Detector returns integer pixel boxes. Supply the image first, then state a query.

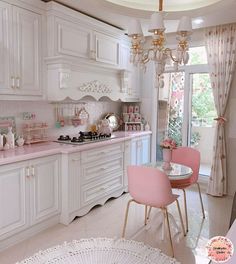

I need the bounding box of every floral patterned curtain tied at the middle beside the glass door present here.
[205,24,236,196]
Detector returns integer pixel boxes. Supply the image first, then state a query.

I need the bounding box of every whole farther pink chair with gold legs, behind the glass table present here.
[170,147,205,232]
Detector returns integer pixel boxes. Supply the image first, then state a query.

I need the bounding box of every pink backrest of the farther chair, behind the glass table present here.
[171,147,200,183]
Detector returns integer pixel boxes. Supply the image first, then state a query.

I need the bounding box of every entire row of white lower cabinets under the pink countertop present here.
[0,135,150,251]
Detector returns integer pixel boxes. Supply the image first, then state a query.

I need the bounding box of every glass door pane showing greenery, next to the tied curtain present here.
[188,73,217,175]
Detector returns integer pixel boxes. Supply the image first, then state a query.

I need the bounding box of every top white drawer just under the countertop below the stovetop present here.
[81,143,124,163]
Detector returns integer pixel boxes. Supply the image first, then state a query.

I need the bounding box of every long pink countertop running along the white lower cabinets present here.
[0,131,151,165]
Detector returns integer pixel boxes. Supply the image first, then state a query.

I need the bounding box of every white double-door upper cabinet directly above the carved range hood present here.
[48,13,120,67]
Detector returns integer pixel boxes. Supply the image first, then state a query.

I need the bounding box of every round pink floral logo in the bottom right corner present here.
[207,236,234,263]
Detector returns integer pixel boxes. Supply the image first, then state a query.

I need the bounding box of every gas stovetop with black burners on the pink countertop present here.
[54,131,114,145]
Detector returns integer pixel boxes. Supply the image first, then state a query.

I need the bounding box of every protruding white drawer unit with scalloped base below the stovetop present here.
[60,142,124,225]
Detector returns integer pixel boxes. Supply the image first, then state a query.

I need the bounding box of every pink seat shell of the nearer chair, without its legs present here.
[128,166,173,207]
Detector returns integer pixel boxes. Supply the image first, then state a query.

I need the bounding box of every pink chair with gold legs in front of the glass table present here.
[122,166,185,256]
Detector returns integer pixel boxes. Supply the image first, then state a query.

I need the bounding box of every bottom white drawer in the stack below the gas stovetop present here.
[81,173,123,207]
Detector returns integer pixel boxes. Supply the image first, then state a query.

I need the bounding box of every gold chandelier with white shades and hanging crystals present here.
[128,0,192,87]
